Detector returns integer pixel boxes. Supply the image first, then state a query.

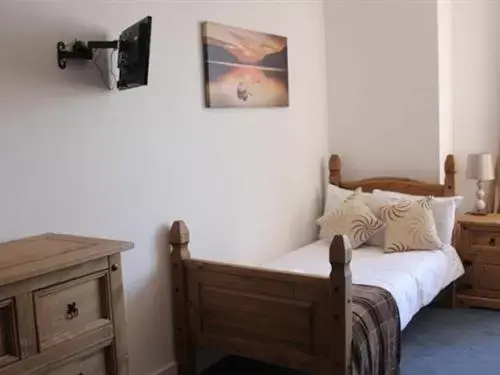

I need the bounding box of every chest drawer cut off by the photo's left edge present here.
[0,299,20,367]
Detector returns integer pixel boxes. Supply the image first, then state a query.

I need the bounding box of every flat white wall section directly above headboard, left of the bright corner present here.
[325,0,441,181]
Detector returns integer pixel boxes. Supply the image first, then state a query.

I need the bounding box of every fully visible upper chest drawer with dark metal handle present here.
[34,271,111,351]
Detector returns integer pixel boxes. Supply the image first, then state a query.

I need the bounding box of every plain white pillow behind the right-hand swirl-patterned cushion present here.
[373,190,464,245]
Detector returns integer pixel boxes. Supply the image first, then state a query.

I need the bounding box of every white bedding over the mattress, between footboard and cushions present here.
[260,240,464,329]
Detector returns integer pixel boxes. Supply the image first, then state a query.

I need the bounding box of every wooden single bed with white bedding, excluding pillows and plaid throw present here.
[169,155,460,375]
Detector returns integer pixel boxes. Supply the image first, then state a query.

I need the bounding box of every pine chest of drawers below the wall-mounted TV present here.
[0,233,133,375]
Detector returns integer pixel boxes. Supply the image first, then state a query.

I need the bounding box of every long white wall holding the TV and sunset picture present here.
[0,0,327,375]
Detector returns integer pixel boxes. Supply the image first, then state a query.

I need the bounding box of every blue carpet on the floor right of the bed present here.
[401,308,500,375]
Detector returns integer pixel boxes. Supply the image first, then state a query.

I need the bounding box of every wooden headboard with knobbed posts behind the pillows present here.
[329,155,455,197]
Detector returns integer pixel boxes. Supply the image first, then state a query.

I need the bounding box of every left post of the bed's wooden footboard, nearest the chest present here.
[169,221,196,375]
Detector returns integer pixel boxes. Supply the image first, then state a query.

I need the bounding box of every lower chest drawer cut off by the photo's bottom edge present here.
[44,348,110,375]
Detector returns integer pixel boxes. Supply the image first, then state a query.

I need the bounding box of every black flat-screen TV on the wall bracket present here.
[117,16,152,90]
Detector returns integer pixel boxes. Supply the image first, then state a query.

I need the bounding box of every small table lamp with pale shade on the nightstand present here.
[466,153,495,215]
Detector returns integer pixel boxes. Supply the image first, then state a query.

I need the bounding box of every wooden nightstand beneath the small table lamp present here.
[456,214,500,309]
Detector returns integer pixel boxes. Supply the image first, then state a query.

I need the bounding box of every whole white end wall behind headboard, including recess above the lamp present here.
[325,0,500,211]
